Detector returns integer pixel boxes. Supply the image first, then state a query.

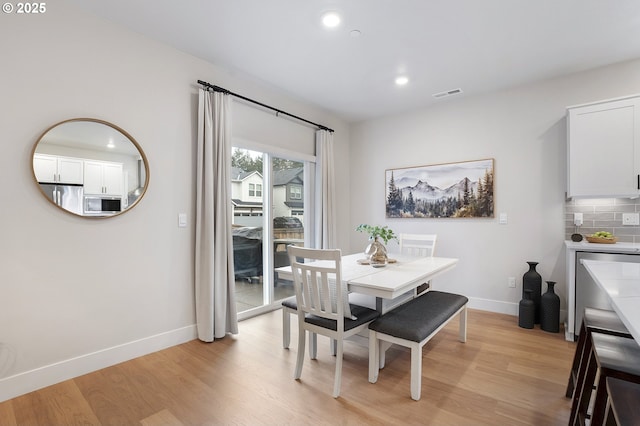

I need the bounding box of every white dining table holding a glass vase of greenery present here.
[276,253,458,311]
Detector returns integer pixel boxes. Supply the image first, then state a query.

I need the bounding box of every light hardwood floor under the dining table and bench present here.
[0,310,575,426]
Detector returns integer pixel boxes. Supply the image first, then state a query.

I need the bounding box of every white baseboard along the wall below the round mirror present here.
[0,325,197,402]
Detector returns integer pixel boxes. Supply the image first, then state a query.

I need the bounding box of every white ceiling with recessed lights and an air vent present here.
[72,0,640,121]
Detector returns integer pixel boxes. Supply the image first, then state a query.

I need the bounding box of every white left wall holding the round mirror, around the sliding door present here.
[0,1,349,401]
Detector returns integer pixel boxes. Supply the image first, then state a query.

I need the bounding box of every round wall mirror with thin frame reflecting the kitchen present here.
[32,118,149,218]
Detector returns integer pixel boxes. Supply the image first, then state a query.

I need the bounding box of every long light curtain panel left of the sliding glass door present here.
[195,89,238,342]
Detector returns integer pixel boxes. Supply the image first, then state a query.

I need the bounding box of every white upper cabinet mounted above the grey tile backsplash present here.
[567,96,640,198]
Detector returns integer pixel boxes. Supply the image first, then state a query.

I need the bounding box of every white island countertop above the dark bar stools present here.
[582,259,640,342]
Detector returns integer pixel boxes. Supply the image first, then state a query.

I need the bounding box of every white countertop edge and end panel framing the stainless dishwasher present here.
[565,240,640,341]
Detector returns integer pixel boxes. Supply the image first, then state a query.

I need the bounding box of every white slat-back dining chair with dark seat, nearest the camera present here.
[288,246,380,398]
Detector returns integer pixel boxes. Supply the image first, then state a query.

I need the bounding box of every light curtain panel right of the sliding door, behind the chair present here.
[315,130,337,249]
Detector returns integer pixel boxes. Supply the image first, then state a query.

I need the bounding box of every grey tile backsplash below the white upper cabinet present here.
[565,198,640,243]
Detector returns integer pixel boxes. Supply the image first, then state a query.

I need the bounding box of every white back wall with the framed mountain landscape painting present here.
[350,61,640,314]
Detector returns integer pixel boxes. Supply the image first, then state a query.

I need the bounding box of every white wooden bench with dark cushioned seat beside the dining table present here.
[369,290,469,401]
